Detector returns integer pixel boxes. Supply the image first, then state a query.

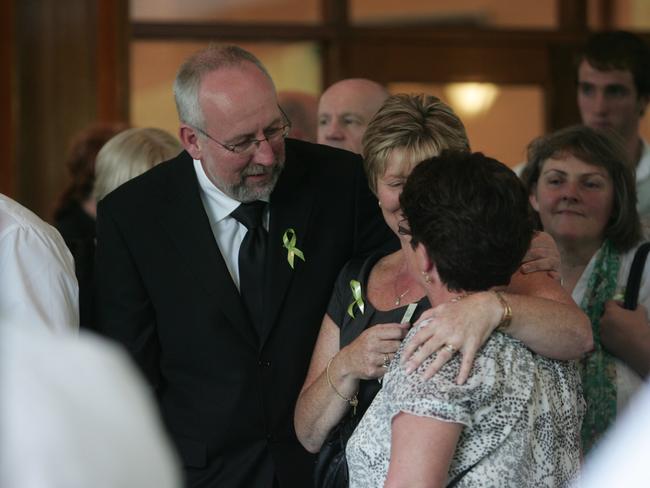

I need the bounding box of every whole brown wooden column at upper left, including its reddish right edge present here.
[13,0,128,218]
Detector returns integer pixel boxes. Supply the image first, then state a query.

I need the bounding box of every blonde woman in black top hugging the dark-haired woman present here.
[294,94,591,487]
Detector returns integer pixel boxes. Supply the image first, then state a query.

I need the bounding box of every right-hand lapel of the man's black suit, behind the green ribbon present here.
[261,147,313,344]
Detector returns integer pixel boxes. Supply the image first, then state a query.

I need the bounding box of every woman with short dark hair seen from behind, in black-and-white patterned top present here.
[347,152,583,488]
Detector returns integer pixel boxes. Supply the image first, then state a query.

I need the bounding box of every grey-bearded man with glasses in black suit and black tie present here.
[96,46,391,488]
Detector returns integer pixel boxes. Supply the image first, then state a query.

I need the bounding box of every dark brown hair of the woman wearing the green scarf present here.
[521,125,641,252]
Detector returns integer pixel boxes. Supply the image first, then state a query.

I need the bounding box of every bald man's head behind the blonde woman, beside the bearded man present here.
[318,78,390,154]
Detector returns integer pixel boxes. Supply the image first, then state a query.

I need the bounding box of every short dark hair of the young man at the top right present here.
[578,31,650,96]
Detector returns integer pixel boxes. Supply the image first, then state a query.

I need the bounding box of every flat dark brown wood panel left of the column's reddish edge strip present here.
[17,0,96,217]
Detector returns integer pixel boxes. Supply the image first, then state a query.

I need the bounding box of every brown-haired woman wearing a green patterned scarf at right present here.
[522,126,650,450]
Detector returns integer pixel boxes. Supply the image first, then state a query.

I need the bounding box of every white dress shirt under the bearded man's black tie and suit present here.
[194,159,269,289]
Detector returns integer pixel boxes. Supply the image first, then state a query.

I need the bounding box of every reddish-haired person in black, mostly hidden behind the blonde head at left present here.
[54,123,127,329]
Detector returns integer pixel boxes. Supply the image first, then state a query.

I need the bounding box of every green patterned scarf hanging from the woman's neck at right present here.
[580,240,620,454]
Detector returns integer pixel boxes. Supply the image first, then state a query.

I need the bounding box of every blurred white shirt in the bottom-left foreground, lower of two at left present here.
[0,322,181,488]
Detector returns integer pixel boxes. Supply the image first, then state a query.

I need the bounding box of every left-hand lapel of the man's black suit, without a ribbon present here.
[159,152,259,347]
